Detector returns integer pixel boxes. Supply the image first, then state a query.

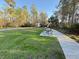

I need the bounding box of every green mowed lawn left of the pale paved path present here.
[0,28,65,59]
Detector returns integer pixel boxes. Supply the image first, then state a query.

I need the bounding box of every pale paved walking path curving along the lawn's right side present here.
[40,29,79,59]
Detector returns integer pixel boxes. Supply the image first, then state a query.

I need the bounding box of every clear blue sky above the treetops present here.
[0,0,59,17]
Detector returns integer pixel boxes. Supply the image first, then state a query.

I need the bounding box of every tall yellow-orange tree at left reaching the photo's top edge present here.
[4,0,16,26]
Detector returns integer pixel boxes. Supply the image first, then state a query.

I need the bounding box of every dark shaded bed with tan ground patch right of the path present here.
[56,29,79,43]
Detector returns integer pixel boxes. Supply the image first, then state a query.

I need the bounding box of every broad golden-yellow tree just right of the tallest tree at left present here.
[14,6,29,27]
